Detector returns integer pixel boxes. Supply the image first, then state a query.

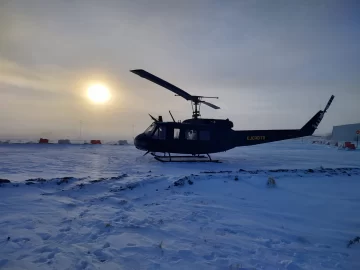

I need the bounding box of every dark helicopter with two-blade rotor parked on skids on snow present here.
[130,69,334,162]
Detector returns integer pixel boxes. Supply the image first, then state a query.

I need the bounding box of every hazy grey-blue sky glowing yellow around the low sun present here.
[0,0,360,139]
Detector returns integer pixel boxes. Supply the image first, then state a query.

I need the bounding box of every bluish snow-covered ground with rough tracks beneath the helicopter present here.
[0,140,360,269]
